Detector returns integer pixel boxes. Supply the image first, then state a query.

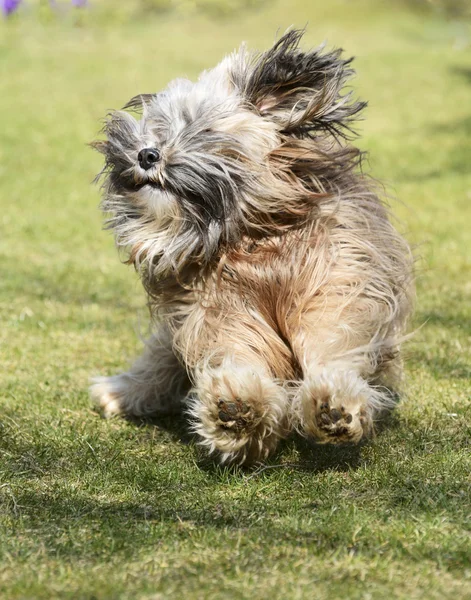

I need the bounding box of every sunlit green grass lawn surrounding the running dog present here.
[0,0,471,600]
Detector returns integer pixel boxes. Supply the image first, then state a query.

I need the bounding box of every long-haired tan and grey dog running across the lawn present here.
[91,30,414,464]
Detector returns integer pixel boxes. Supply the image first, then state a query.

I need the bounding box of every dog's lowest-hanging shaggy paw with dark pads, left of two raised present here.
[190,353,288,464]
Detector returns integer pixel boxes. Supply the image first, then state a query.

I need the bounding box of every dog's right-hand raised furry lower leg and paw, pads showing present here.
[292,311,401,444]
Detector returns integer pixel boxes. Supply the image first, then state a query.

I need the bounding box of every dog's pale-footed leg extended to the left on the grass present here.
[90,326,190,417]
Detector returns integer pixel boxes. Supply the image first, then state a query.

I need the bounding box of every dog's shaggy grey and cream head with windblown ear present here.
[95,31,363,278]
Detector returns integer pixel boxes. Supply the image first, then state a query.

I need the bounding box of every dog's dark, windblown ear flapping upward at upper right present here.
[233,30,366,137]
